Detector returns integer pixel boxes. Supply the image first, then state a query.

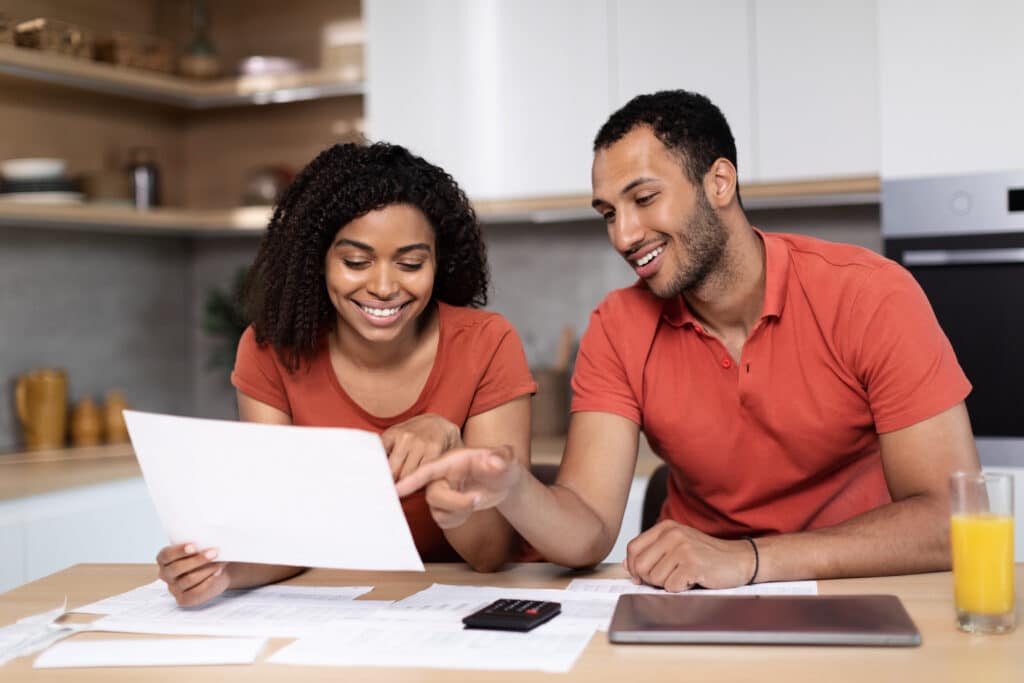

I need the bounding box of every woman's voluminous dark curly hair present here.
[242,142,488,371]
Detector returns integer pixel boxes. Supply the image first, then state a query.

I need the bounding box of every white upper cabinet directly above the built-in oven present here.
[879,0,1024,179]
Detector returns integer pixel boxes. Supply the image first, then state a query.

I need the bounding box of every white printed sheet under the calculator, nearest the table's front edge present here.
[267,616,594,673]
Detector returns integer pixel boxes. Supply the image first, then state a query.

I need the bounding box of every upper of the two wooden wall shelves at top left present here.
[0,45,364,110]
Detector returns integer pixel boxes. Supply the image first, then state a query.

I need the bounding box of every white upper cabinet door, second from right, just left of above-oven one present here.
[753,0,880,181]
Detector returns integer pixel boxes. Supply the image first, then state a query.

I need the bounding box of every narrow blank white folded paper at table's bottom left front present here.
[33,638,266,669]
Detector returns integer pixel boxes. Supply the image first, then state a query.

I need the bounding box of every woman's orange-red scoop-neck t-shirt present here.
[231,302,537,562]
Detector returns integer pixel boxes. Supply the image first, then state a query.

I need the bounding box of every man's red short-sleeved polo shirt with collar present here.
[572,231,971,538]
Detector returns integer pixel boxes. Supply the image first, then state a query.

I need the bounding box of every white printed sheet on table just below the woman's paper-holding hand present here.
[90,586,391,638]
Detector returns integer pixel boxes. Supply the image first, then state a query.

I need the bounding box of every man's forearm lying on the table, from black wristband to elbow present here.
[757,496,950,582]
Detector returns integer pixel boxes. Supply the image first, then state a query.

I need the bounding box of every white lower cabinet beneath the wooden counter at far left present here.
[0,477,167,591]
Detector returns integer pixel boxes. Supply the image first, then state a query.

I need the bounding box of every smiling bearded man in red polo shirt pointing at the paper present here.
[398,91,979,591]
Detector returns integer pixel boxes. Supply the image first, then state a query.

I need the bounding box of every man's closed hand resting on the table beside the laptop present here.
[624,520,754,593]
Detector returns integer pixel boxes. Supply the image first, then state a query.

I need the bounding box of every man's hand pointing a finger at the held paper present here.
[395,449,522,528]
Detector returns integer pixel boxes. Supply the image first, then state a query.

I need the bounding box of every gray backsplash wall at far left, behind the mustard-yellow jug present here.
[0,228,193,450]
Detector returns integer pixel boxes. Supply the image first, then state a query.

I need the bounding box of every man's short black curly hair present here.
[594,90,742,206]
